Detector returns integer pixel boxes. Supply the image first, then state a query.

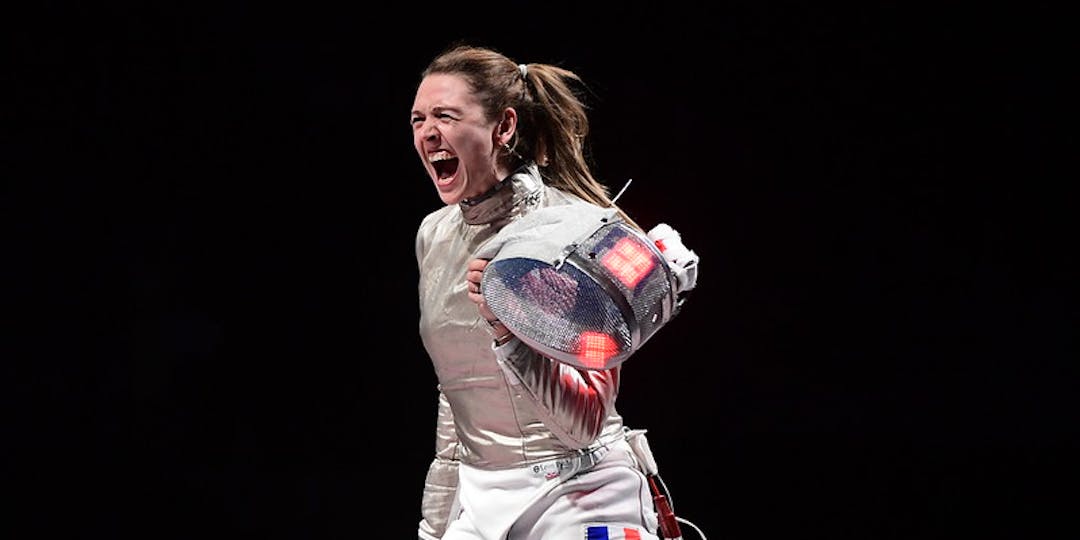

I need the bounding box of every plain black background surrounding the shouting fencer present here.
[3,1,1077,540]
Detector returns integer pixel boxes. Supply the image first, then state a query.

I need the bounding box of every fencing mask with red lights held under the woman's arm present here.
[476,204,698,369]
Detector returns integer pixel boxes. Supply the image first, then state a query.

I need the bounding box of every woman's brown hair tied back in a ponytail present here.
[420,43,640,229]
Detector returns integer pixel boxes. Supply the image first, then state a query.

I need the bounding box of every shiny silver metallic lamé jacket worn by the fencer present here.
[416,165,622,538]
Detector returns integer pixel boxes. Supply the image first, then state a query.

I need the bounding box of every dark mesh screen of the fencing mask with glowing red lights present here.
[481,224,672,368]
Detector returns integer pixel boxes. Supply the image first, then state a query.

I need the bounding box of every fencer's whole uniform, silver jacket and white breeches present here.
[416,165,658,540]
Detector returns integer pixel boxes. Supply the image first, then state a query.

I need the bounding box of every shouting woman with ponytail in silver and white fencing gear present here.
[410,45,695,540]
